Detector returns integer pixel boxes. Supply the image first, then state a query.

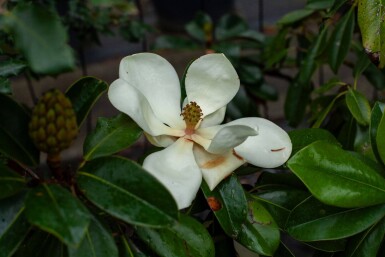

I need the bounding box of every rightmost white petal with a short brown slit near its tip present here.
[228,118,292,168]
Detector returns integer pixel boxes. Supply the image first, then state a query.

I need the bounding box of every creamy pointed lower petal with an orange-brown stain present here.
[194,145,245,190]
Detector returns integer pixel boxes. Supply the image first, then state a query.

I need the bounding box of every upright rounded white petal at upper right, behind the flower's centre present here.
[185,54,239,116]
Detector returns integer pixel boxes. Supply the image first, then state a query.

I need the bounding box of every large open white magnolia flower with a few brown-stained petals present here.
[108,53,292,209]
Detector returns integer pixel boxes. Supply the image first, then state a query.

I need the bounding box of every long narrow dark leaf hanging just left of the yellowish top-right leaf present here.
[328,8,355,73]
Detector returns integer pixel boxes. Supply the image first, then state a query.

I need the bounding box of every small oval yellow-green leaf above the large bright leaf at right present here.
[345,89,370,126]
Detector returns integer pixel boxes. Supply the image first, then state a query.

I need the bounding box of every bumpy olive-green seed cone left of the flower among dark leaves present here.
[29,89,78,154]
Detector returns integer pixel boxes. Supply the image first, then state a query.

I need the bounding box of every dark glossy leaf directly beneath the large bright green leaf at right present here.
[286,197,385,241]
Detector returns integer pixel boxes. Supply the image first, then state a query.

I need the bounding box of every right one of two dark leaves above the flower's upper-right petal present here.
[215,14,249,40]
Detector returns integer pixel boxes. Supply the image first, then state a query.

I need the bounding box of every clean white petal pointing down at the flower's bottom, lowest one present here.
[143,138,202,209]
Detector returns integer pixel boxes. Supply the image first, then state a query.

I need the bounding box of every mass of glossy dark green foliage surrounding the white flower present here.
[0,0,385,254]
